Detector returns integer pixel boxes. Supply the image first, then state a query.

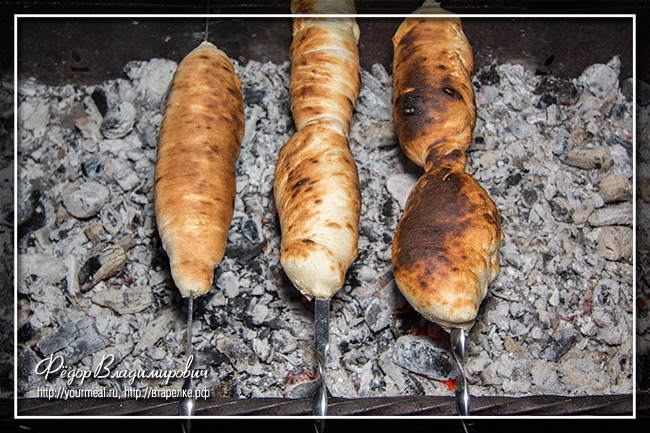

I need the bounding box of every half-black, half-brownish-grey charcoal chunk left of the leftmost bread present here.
[78,244,127,291]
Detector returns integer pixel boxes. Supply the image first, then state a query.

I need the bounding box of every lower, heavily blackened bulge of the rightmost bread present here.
[392,167,503,326]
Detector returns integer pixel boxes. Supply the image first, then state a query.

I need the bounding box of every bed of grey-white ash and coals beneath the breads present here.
[17,51,632,398]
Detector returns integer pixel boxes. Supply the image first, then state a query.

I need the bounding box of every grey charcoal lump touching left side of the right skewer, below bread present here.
[393,335,458,381]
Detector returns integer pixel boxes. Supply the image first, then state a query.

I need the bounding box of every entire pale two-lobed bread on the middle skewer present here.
[274,0,361,299]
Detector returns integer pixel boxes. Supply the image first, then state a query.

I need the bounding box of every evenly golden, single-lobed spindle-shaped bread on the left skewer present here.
[154,42,244,297]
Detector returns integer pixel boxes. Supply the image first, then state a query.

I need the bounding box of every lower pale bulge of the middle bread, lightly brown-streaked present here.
[274,123,361,298]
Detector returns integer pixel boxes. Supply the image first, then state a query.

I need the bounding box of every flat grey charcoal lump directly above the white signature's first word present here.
[37,317,109,365]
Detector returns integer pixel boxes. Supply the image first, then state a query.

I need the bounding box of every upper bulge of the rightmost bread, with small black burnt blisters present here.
[393,11,476,166]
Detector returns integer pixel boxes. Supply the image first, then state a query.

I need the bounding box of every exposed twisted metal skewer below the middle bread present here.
[311,298,330,433]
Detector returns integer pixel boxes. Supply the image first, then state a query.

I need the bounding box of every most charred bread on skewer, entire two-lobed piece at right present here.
[392,2,503,330]
